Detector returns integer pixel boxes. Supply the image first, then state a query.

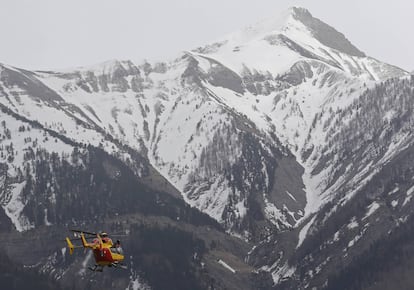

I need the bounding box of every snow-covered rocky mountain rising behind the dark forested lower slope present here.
[0,8,414,288]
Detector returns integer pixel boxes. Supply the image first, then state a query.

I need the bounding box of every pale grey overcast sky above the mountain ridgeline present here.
[0,0,414,71]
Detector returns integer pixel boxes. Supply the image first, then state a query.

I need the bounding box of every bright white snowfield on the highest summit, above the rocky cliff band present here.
[196,8,407,80]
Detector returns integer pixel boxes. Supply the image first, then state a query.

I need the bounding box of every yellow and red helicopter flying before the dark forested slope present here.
[66,229,126,272]
